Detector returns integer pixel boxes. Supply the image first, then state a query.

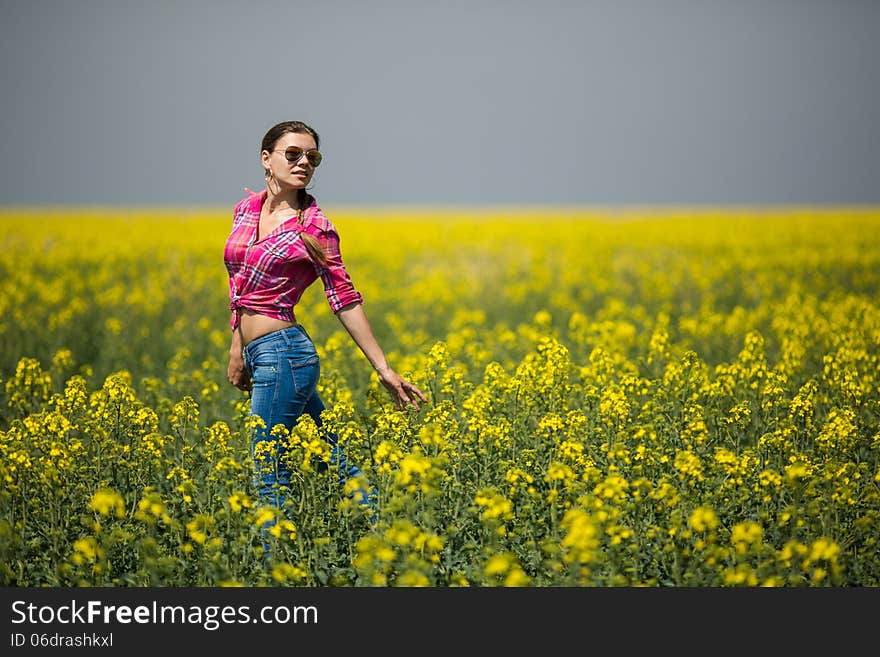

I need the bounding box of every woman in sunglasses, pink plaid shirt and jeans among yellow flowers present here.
[224,121,426,548]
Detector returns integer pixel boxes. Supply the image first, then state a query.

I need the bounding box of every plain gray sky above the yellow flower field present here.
[0,0,880,206]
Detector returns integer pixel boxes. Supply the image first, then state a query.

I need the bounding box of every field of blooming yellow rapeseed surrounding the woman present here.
[0,207,880,587]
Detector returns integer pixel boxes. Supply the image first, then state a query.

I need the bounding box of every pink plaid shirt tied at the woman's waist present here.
[229,190,364,329]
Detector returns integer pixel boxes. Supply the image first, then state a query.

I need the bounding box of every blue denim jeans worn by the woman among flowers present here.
[244,325,377,532]
